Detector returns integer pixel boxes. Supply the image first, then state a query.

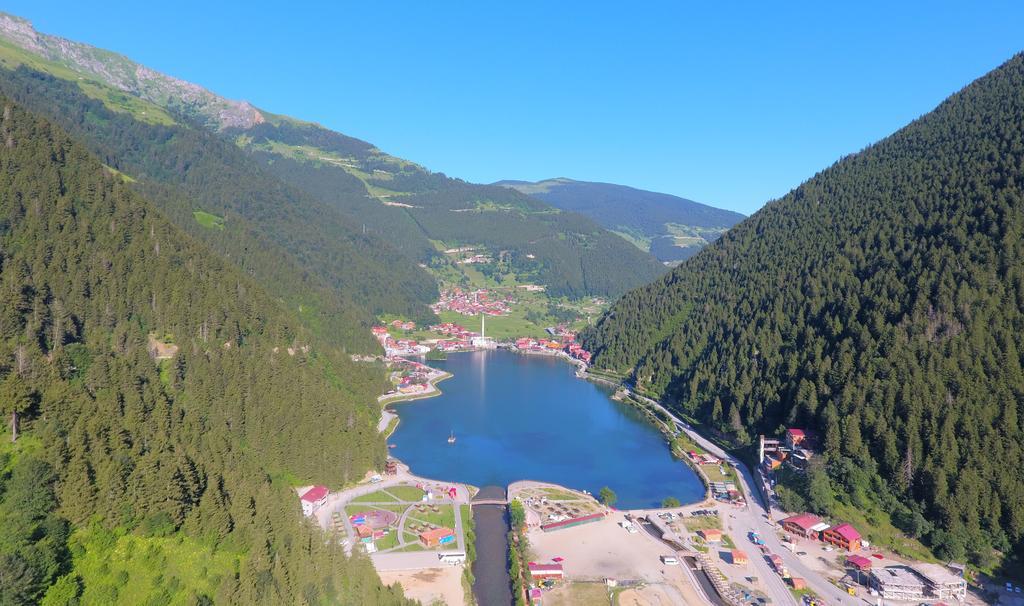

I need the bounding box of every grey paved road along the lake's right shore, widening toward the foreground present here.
[626,388,870,606]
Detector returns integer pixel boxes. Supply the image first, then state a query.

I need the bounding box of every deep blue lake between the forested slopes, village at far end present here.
[390,350,703,509]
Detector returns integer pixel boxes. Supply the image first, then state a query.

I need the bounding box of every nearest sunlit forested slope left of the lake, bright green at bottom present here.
[0,98,402,604]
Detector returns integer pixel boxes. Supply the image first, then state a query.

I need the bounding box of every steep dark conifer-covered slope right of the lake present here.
[584,55,1024,564]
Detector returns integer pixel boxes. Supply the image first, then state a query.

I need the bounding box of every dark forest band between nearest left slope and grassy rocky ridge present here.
[0,67,437,351]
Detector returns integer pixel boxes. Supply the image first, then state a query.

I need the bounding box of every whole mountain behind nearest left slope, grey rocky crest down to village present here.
[0,13,664,303]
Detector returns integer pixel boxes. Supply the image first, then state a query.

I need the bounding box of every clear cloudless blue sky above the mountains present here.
[2,0,1024,214]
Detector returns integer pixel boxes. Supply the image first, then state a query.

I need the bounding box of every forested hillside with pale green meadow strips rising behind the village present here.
[234,105,664,298]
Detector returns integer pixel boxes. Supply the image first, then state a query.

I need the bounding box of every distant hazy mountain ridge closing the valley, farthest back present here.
[495,177,745,263]
